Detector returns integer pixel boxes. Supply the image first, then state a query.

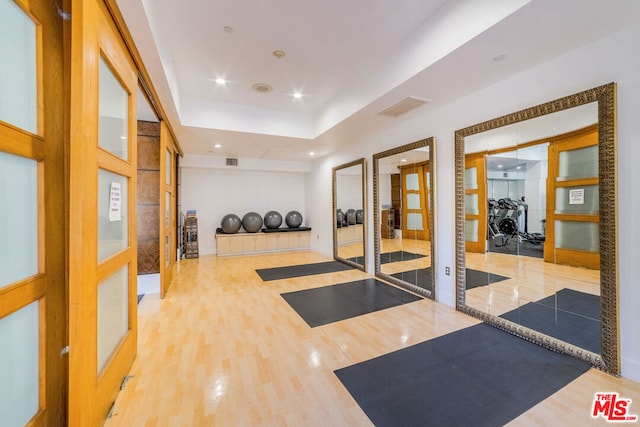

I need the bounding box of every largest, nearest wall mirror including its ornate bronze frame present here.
[455,83,619,374]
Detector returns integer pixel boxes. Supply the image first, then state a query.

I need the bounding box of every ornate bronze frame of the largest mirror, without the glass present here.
[455,83,620,374]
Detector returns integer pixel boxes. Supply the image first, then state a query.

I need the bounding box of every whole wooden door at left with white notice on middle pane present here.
[69,0,138,426]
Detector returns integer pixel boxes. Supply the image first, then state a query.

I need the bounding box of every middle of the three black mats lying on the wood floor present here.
[281,278,422,328]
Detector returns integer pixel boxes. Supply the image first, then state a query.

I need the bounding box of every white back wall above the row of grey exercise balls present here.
[180,156,313,255]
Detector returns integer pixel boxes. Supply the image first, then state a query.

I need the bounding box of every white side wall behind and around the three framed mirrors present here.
[307,25,640,381]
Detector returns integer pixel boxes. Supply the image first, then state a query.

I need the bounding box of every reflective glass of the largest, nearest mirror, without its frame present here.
[465,102,601,354]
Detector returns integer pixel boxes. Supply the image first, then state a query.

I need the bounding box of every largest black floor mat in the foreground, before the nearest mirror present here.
[335,324,589,426]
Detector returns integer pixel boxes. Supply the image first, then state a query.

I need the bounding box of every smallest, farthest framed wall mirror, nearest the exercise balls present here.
[333,159,367,271]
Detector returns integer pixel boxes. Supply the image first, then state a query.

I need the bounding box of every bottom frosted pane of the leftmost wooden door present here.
[0,300,40,427]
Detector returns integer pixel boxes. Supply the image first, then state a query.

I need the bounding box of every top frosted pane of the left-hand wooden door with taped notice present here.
[98,57,129,160]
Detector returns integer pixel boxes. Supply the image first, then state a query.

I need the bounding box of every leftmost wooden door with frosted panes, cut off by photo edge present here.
[0,0,67,426]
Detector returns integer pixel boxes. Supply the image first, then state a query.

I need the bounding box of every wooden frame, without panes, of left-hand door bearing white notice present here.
[68,0,137,426]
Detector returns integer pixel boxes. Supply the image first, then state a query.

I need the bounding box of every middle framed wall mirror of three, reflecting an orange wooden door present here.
[373,138,435,298]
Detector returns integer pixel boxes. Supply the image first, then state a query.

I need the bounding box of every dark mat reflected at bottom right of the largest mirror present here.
[500,289,601,353]
